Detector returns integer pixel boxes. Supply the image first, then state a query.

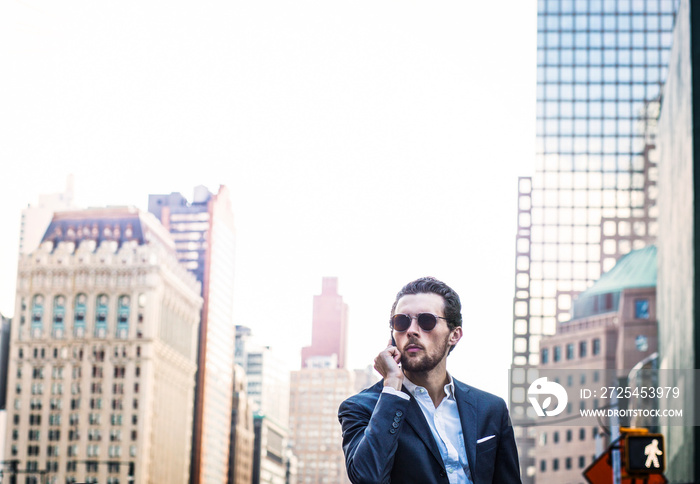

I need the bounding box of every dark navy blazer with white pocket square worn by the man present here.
[338,380,521,484]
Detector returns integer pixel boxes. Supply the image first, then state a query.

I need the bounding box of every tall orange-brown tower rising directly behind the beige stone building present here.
[148,186,236,484]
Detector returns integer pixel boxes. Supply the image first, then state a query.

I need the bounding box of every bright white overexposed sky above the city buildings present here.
[0,0,537,398]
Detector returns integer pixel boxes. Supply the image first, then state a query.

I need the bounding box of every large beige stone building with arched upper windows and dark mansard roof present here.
[4,208,202,484]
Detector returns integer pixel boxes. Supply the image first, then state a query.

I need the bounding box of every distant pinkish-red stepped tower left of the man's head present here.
[301,277,348,368]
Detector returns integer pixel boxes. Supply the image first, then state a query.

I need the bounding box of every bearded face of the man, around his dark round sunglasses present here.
[392,293,462,373]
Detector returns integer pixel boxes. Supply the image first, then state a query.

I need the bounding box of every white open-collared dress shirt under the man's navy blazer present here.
[383,375,473,484]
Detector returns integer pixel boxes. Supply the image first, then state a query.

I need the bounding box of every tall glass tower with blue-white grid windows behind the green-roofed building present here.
[510,0,678,483]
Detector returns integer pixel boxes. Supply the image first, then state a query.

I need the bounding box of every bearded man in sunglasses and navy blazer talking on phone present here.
[338,277,521,484]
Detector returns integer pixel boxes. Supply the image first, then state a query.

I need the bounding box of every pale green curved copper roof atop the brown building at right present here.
[579,245,656,299]
